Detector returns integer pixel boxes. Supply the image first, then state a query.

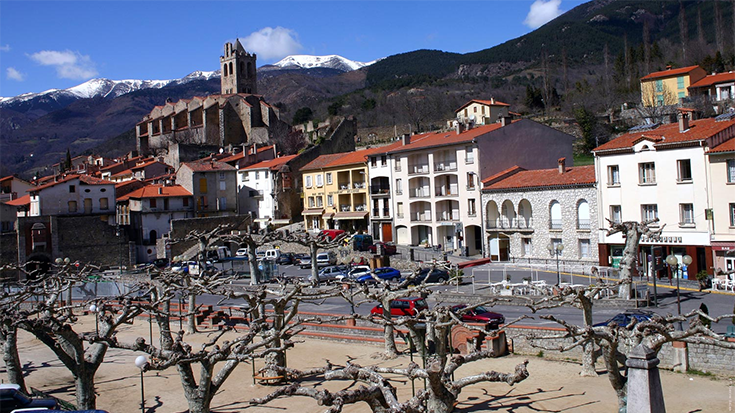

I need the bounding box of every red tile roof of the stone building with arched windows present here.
[483,165,595,191]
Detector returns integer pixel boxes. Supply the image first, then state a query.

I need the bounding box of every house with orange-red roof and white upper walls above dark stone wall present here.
[116,184,194,262]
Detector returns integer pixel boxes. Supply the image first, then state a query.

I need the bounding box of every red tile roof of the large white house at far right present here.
[593,118,735,152]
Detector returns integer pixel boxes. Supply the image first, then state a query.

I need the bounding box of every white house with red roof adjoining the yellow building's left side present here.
[237,155,301,228]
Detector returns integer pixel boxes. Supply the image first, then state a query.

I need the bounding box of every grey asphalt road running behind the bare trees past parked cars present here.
[201,264,735,333]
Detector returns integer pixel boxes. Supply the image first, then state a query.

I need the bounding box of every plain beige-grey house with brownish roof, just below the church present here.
[176,158,237,217]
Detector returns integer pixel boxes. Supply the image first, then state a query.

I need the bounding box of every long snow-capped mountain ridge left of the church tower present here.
[0,70,219,106]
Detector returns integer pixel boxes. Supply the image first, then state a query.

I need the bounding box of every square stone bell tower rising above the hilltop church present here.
[219,40,258,95]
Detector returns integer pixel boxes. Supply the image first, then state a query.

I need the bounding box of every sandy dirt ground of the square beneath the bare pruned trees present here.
[8,316,735,413]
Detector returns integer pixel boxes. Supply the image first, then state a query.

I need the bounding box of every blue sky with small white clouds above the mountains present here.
[0,0,584,97]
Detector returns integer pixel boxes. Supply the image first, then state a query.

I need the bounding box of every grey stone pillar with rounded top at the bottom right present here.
[625,344,666,413]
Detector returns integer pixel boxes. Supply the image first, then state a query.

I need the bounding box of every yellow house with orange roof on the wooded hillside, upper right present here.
[641,66,707,107]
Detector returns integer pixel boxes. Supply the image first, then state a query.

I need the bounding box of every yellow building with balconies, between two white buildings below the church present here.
[301,148,380,232]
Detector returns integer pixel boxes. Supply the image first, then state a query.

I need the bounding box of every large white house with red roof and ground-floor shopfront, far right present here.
[593,109,735,279]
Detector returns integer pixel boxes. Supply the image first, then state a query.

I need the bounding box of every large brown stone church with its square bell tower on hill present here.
[135,40,291,159]
